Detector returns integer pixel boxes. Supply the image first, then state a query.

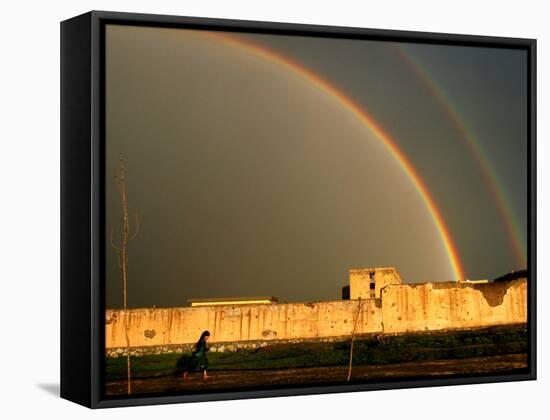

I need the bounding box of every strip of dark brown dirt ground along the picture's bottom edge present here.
[106,354,527,396]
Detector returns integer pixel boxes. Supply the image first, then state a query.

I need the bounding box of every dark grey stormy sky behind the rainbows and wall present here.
[106,26,527,307]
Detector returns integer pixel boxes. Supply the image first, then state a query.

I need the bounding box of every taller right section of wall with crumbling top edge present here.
[382,279,527,333]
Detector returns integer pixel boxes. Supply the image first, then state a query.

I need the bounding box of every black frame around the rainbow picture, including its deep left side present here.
[61,11,537,408]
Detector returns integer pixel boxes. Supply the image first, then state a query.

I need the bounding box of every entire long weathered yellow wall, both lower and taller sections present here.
[105,279,527,349]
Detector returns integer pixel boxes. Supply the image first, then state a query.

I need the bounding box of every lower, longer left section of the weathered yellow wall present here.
[105,299,382,348]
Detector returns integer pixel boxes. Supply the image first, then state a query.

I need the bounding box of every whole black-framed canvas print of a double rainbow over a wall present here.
[61,12,536,408]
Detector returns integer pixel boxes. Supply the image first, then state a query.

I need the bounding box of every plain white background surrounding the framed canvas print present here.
[0,0,550,420]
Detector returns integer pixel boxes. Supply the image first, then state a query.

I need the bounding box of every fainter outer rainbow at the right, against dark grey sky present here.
[393,44,527,268]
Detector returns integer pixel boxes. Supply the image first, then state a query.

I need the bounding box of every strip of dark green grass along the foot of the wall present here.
[106,325,528,380]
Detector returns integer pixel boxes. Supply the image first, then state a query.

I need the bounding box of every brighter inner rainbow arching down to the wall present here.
[204,32,464,281]
